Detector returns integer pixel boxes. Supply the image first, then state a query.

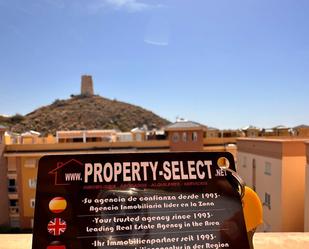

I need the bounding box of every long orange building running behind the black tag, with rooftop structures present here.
[0,127,236,229]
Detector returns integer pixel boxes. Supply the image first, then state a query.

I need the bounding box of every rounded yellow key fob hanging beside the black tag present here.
[242,186,263,232]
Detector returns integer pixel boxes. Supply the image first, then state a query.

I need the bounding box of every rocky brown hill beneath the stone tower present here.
[0,95,169,135]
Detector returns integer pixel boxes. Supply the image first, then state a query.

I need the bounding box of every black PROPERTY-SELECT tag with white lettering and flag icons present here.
[32,152,250,249]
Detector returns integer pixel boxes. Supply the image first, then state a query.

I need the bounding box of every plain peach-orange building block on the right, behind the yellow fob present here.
[237,138,306,232]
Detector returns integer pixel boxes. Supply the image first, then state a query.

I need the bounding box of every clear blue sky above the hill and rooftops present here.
[0,0,309,128]
